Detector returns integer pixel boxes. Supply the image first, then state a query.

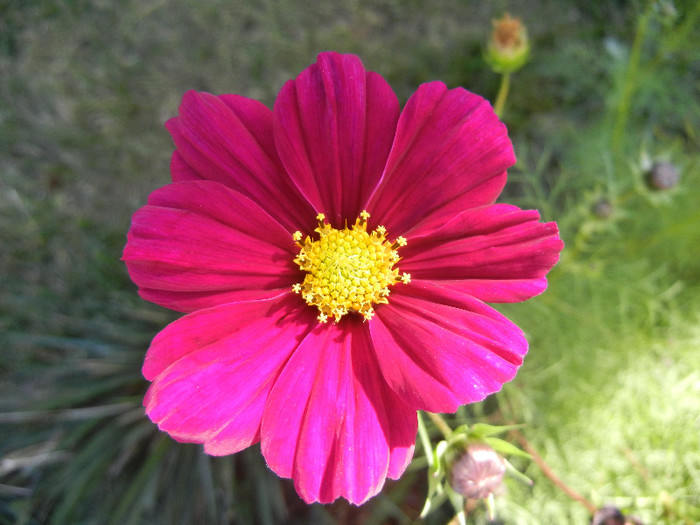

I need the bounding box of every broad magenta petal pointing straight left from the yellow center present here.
[123,181,300,311]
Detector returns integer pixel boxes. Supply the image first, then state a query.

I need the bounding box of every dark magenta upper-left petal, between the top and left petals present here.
[166,91,315,232]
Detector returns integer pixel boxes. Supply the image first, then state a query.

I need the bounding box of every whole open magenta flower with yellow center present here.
[124,53,562,504]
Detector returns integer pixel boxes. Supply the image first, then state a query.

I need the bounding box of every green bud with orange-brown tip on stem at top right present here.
[485,13,530,73]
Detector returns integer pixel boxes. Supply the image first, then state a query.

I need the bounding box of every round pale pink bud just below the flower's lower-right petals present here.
[448,442,506,499]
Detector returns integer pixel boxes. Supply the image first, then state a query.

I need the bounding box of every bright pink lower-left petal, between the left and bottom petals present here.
[143,294,316,455]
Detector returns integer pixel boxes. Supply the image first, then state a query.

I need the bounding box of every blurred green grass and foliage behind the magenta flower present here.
[0,0,700,525]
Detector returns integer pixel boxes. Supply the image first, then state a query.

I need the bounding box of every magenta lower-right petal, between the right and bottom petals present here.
[369,281,527,412]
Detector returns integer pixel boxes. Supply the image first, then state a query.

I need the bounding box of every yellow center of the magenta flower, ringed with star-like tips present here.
[292,211,411,323]
